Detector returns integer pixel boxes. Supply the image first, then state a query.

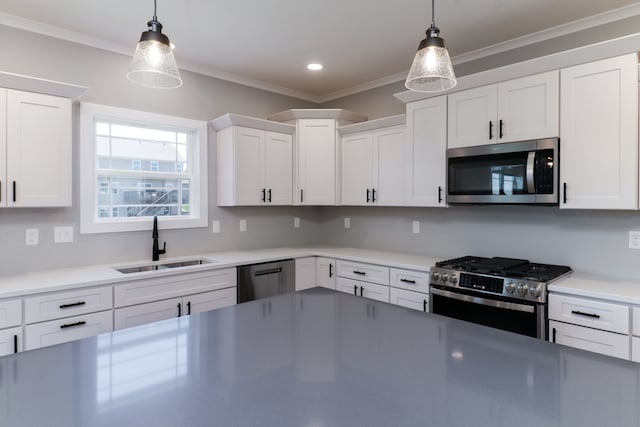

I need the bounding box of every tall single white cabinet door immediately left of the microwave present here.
[406,96,447,207]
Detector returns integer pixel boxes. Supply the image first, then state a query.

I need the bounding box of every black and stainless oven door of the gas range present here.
[430,285,546,339]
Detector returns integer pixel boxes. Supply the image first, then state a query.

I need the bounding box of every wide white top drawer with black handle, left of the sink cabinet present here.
[24,286,113,323]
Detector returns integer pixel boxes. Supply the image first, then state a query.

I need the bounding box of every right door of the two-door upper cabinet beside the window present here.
[264,132,293,205]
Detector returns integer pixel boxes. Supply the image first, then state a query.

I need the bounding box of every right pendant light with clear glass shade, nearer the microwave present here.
[404,0,458,92]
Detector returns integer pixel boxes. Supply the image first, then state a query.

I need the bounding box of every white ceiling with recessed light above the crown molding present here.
[0,0,640,100]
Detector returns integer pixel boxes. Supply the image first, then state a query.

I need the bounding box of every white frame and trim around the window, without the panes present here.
[80,102,209,234]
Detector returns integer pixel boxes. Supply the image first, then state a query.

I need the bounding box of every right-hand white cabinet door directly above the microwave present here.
[498,71,560,142]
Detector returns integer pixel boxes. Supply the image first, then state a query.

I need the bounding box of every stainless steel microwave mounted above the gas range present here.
[447,138,560,205]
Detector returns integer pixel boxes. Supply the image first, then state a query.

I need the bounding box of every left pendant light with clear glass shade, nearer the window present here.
[127,0,182,89]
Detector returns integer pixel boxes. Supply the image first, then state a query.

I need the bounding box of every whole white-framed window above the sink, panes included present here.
[80,103,207,233]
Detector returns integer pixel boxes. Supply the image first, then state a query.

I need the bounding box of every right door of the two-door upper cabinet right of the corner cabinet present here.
[372,125,407,206]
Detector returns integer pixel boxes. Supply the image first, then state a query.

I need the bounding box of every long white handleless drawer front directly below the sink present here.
[114,268,236,307]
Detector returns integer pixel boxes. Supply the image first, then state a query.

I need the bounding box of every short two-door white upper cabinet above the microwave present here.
[448,71,559,148]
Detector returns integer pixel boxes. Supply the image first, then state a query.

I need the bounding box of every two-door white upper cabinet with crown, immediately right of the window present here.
[212,114,295,206]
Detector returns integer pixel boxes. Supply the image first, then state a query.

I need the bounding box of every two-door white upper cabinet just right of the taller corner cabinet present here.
[339,115,407,206]
